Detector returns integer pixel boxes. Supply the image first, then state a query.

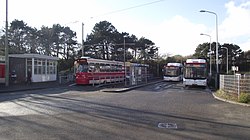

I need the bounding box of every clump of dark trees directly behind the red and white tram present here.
[84,21,158,62]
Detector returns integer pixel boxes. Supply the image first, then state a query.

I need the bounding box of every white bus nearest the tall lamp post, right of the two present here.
[183,59,207,87]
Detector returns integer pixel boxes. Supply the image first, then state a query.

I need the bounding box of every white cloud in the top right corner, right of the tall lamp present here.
[219,1,250,51]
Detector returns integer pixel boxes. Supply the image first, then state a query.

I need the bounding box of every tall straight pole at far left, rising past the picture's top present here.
[5,0,9,86]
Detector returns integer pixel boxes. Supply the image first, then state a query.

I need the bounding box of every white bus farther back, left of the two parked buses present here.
[163,63,183,81]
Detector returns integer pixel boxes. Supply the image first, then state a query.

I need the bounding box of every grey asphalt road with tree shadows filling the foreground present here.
[0,82,250,140]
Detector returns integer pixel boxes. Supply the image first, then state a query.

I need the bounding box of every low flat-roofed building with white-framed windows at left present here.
[9,54,59,83]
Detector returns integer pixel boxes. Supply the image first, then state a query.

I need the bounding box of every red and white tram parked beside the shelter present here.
[75,57,124,85]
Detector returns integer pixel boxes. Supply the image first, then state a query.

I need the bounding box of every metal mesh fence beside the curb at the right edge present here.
[220,74,250,98]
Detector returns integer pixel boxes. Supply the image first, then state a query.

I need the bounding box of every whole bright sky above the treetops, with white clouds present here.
[0,0,250,56]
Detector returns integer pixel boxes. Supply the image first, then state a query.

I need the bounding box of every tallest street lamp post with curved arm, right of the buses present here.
[200,10,219,89]
